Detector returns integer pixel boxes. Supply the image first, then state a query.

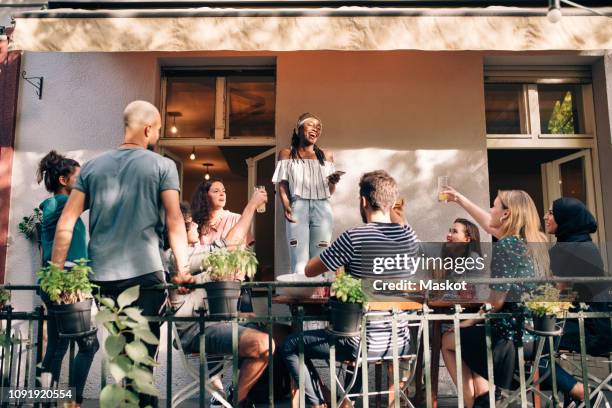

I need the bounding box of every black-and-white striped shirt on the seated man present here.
[319,223,420,354]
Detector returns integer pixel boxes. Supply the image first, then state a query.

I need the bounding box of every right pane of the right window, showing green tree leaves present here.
[538,84,584,134]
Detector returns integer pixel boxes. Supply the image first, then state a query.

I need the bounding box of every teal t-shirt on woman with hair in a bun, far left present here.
[39,194,87,266]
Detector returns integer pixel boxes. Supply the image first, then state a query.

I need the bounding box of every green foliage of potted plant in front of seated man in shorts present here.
[202,248,257,281]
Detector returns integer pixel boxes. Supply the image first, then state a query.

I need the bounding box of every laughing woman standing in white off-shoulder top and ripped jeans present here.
[272,113,340,273]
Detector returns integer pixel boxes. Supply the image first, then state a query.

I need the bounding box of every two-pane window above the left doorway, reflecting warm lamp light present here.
[163,69,276,144]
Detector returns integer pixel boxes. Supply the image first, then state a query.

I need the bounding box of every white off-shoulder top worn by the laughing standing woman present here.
[272,159,336,200]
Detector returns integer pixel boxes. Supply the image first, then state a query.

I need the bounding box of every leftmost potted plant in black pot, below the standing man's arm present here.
[36,259,95,337]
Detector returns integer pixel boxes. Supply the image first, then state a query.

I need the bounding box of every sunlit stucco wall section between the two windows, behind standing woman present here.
[276,52,488,275]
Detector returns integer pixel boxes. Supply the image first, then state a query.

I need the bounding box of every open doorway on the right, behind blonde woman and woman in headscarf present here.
[488,149,600,242]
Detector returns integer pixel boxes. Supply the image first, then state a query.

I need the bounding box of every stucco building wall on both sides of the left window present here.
[6,52,488,398]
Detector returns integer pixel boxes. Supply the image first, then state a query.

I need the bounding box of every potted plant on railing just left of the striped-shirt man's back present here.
[329,273,366,335]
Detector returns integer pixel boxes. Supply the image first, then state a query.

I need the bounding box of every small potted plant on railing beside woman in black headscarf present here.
[522,285,572,332]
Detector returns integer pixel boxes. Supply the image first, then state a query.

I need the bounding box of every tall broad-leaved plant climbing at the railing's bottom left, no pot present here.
[96,286,159,408]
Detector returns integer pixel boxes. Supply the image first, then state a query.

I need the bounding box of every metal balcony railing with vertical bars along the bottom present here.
[0,277,612,408]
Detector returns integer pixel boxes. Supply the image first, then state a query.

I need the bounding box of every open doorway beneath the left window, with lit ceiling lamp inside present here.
[161,145,275,281]
